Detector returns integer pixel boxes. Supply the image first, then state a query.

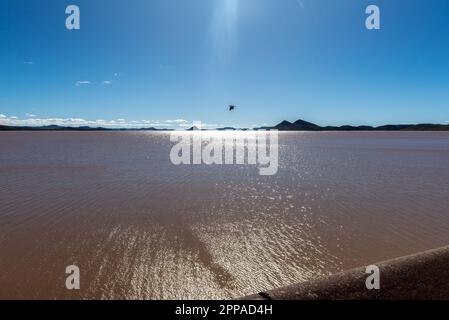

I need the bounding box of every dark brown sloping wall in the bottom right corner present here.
[243,246,449,300]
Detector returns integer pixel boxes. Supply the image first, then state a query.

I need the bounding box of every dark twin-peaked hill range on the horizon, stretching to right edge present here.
[272,120,449,131]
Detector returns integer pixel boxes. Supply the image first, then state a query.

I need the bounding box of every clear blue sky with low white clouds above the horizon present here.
[0,0,449,127]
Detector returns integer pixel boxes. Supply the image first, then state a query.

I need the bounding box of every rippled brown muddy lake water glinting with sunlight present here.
[0,132,449,299]
